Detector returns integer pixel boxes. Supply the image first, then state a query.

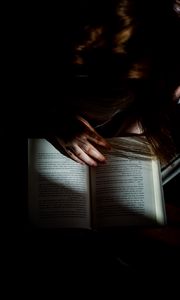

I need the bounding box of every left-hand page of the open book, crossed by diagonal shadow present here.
[28,139,90,228]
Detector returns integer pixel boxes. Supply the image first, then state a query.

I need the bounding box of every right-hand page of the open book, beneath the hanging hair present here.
[91,138,166,228]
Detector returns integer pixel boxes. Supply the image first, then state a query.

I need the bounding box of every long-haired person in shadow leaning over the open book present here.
[43,0,180,166]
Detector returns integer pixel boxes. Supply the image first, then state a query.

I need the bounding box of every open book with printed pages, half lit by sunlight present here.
[28,137,166,229]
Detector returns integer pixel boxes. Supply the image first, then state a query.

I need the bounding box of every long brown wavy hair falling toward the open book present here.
[60,0,180,160]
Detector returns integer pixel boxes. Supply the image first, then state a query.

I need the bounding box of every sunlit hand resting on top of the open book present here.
[48,116,111,166]
